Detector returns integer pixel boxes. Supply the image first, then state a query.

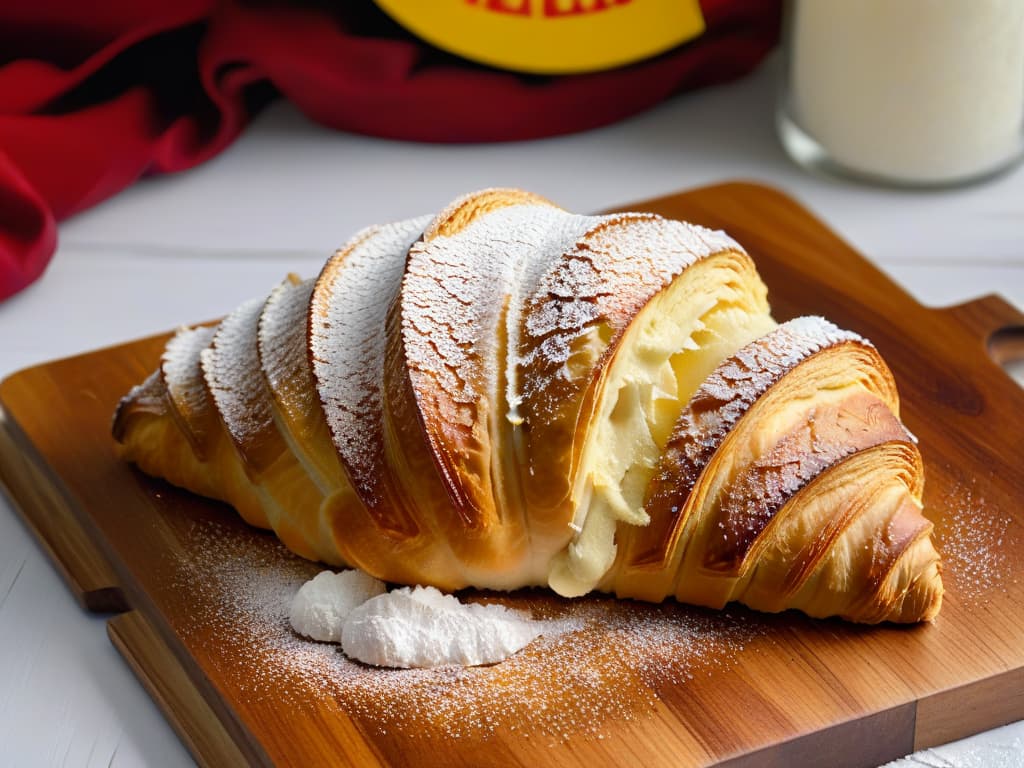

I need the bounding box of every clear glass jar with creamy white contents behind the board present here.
[776,0,1024,186]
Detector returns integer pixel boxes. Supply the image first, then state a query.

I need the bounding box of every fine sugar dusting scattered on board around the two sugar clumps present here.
[174,521,764,739]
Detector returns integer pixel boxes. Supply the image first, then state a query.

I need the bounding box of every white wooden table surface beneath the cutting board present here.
[0,61,1024,768]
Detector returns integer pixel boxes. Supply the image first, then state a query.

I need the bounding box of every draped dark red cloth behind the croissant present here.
[0,0,779,299]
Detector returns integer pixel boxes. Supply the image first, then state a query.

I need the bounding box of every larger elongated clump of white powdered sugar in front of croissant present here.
[341,587,544,669]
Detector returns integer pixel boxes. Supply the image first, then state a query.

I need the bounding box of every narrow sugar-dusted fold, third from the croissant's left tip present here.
[200,299,278,470]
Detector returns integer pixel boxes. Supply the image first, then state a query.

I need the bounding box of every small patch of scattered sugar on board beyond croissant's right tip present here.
[935,482,1014,601]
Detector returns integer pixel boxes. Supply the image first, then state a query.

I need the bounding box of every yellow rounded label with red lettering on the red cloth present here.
[376,0,705,75]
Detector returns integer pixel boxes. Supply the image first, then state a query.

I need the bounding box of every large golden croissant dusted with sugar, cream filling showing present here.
[113,189,942,623]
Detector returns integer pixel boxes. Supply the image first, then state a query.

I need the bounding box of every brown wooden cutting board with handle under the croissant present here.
[6,183,1024,768]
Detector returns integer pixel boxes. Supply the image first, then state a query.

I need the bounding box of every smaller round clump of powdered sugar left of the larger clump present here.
[288,569,386,643]
